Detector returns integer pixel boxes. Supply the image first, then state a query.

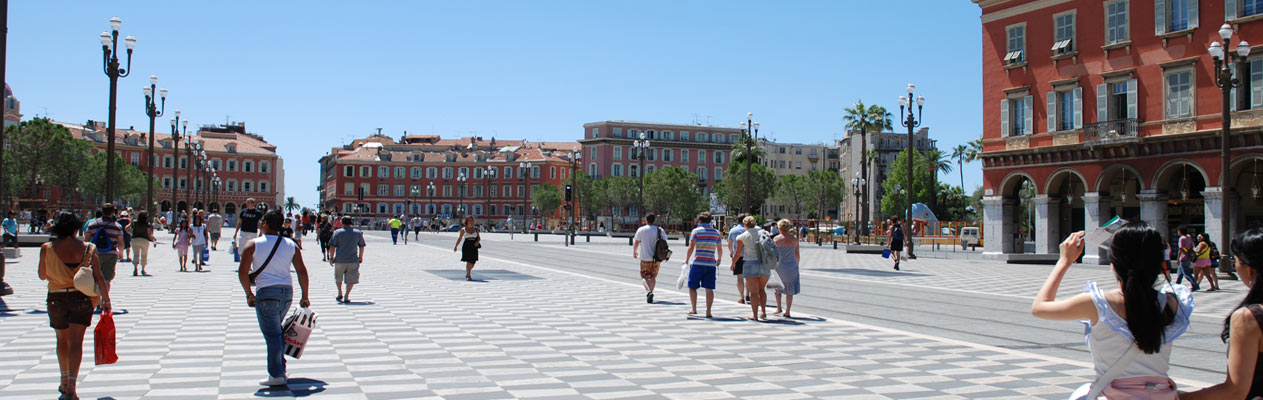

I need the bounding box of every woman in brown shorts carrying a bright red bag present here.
[38,212,111,399]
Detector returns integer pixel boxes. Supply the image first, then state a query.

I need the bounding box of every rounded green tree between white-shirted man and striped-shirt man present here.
[644,167,710,227]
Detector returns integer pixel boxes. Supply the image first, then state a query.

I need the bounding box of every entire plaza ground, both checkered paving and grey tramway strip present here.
[0,231,1244,399]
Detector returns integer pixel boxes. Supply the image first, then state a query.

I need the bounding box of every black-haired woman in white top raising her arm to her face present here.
[1031,221,1192,399]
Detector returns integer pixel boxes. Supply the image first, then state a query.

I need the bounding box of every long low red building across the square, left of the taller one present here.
[317,134,581,227]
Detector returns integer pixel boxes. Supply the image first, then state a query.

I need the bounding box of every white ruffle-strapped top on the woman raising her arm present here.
[1081,281,1192,379]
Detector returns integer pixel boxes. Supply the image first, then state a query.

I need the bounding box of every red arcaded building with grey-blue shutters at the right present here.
[971,0,1263,262]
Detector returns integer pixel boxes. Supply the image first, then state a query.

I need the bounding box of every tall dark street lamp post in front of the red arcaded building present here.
[1210,23,1250,274]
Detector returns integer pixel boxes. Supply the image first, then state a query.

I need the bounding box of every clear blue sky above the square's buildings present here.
[8,0,983,206]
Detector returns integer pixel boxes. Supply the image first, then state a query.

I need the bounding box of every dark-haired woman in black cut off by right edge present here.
[1180,228,1263,400]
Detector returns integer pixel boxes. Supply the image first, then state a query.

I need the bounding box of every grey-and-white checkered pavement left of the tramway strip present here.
[0,232,1182,399]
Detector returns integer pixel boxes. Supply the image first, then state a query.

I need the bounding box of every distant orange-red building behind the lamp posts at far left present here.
[56,121,285,222]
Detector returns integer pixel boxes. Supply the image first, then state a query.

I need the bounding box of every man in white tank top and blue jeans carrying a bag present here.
[237,209,311,386]
